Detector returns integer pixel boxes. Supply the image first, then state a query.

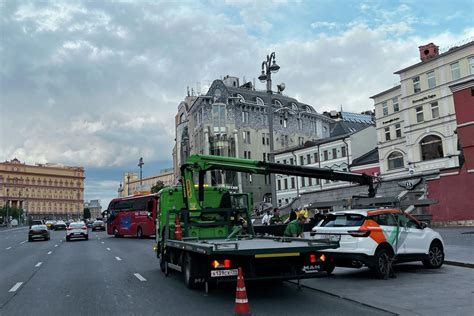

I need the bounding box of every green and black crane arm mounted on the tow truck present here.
[181,155,375,210]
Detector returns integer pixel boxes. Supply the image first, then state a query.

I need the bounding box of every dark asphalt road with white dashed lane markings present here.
[0,229,391,315]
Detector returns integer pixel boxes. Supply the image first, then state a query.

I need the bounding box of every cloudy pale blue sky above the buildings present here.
[0,0,474,208]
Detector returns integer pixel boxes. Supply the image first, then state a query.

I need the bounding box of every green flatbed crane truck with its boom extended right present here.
[155,155,374,291]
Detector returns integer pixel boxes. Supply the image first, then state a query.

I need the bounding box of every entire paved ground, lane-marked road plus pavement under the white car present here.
[0,228,474,315]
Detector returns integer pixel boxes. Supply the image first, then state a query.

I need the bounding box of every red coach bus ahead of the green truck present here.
[104,193,158,238]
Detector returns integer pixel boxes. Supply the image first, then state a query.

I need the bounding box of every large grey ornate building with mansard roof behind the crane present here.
[173,76,333,202]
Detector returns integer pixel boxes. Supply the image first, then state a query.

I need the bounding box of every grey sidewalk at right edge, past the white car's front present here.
[434,227,474,268]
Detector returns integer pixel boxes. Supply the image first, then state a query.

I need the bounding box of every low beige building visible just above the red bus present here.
[119,168,175,197]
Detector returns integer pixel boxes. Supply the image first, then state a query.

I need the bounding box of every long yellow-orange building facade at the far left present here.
[0,158,85,219]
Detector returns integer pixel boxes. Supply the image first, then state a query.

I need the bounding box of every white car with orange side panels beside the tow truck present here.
[311,209,444,278]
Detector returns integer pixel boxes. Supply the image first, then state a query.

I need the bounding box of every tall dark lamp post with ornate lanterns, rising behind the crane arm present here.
[258,52,280,207]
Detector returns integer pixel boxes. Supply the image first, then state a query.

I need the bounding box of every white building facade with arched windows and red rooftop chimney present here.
[371,42,474,179]
